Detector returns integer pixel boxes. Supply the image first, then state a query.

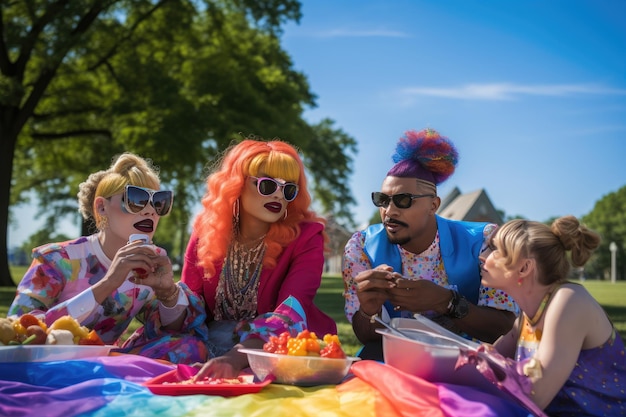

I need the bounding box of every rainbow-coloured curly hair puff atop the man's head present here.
[387,129,459,185]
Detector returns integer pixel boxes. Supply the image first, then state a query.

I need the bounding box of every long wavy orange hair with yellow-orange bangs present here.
[194,139,328,279]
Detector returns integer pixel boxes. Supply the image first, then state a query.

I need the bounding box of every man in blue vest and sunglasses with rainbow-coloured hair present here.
[343,129,517,361]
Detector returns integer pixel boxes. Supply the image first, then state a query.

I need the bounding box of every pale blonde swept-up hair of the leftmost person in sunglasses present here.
[78,152,161,228]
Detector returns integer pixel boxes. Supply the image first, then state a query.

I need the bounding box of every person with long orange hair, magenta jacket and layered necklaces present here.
[181,139,337,378]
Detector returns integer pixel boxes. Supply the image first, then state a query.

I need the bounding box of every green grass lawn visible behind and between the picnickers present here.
[0,267,626,355]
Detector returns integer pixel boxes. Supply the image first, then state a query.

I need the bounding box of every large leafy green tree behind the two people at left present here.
[0,0,356,285]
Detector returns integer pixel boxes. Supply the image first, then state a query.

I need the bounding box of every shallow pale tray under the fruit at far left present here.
[0,345,115,362]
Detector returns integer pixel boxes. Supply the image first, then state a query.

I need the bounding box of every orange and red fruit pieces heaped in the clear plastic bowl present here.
[263,330,346,359]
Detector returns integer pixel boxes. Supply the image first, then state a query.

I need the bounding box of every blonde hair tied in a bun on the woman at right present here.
[493,216,601,285]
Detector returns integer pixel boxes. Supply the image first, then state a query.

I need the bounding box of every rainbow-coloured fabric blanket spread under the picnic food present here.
[0,355,532,417]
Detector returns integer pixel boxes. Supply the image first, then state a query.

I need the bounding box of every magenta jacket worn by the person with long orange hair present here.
[181,223,337,335]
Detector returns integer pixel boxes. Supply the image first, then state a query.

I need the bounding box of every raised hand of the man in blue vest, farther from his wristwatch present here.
[354,265,399,315]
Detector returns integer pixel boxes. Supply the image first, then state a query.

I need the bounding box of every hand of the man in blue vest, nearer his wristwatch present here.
[387,278,452,314]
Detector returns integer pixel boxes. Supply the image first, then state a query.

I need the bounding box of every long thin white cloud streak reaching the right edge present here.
[401,83,626,101]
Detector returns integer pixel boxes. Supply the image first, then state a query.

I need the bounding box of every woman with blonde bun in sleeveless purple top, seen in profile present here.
[482,216,626,416]
